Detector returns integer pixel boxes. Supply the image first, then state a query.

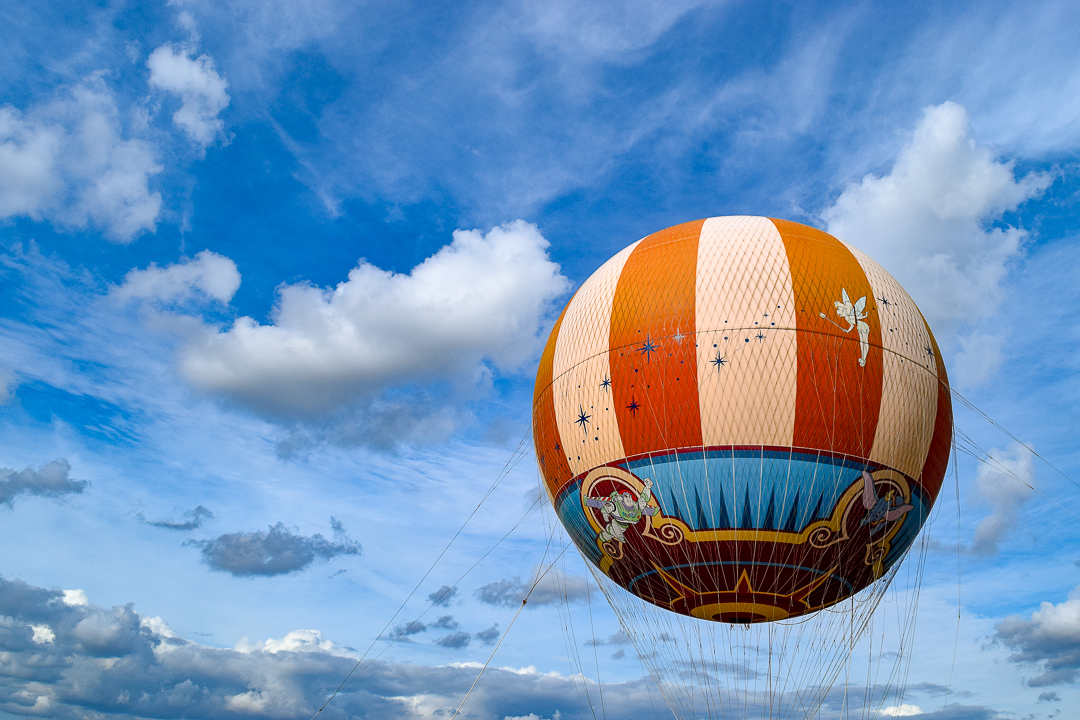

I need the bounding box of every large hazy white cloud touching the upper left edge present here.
[0,78,161,243]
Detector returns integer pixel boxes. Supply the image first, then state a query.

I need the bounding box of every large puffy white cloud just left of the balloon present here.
[180,220,568,419]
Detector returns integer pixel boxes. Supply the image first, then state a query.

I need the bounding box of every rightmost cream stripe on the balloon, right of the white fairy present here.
[845,243,937,478]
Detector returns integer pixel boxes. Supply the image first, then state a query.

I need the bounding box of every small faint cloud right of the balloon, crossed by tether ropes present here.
[969,443,1035,556]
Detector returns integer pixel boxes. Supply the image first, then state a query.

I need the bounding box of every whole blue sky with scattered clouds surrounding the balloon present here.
[0,0,1080,720]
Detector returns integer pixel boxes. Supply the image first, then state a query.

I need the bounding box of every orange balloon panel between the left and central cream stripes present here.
[608,220,705,456]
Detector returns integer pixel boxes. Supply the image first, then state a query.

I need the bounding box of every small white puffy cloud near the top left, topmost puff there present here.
[146,44,229,148]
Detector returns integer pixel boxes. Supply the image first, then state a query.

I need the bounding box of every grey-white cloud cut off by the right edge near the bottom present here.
[994,587,1080,688]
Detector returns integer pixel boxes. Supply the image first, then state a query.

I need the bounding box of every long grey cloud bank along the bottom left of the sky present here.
[0,578,673,720]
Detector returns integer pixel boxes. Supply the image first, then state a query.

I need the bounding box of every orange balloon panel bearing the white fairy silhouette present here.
[770,218,883,458]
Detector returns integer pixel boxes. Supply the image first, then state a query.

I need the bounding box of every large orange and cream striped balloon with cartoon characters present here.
[532,216,953,710]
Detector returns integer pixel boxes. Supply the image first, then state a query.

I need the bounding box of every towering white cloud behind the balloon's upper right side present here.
[822,103,1051,356]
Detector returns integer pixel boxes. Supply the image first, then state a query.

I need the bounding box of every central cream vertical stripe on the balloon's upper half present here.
[696,216,797,447]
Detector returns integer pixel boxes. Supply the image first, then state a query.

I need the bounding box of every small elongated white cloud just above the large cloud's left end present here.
[112,250,240,303]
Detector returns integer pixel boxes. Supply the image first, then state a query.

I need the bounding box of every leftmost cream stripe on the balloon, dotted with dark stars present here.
[552,241,640,476]
